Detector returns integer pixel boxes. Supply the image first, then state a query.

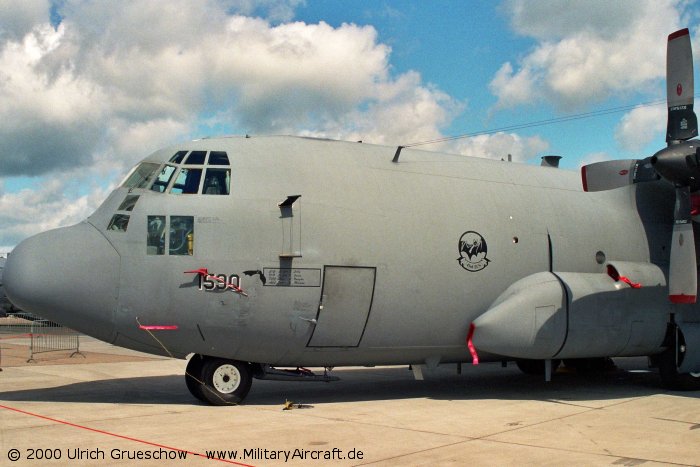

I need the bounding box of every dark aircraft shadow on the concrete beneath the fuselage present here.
[0,365,700,405]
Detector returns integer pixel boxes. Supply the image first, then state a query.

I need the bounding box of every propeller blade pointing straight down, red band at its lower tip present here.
[668,186,698,303]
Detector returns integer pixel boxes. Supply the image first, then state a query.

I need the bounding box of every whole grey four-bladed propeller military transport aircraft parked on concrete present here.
[4,29,700,405]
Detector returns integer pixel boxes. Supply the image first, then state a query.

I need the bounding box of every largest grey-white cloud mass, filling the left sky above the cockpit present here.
[0,0,482,249]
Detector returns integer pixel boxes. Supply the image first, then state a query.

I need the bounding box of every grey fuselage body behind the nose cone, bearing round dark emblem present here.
[31,137,695,366]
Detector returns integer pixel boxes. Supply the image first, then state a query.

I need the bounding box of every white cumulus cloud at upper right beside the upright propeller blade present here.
[490,0,682,111]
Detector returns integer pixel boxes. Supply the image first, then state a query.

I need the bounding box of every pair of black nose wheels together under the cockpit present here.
[185,355,253,405]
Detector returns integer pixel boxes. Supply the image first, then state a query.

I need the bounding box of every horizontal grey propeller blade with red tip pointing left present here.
[581,157,661,191]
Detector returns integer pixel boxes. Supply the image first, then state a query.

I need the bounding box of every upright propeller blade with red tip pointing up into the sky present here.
[666,28,698,143]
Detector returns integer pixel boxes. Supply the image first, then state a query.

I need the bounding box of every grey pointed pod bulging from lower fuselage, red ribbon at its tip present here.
[472,261,669,359]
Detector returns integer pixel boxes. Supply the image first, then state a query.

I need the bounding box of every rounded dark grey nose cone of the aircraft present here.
[3,222,119,341]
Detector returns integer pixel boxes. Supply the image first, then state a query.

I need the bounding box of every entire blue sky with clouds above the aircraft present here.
[0,0,700,253]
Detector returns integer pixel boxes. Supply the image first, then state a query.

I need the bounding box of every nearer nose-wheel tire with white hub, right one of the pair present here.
[201,358,253,405]
